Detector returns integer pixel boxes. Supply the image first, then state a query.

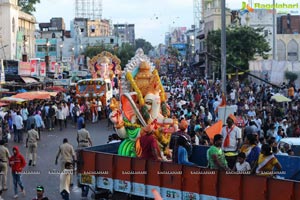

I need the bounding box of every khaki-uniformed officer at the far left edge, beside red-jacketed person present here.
[0,140,10,190]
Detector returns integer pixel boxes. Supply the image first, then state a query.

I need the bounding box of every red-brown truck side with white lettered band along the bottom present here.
[78,144,300,200]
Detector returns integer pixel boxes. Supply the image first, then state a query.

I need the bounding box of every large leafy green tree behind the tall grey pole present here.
[206,26,271,73]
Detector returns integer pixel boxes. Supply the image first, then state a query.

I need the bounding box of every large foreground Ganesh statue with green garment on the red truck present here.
[109,49,178,158]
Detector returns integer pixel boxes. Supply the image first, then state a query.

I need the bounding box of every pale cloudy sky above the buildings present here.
[34,0,297,45]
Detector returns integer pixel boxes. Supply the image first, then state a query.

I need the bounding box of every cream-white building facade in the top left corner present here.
[0,0,36,60]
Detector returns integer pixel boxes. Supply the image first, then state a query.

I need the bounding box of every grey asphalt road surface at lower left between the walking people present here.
[2,119,113,200]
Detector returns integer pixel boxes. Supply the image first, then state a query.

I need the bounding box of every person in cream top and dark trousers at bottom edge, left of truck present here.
[59,162,73,200]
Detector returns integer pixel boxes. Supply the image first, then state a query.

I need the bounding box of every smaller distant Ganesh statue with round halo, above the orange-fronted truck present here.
[88,51,121,80]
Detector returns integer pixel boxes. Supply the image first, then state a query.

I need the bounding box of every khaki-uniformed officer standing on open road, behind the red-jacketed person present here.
[26,124,39,166]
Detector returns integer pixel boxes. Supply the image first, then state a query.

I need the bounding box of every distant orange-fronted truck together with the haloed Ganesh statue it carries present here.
[76,51,121,105]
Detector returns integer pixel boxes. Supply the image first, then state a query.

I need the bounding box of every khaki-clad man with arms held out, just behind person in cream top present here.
[55,138,76,185]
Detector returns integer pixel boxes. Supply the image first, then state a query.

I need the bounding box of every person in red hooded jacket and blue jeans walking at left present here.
[9,146,26,199]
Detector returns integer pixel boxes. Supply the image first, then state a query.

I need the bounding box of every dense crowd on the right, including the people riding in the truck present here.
[157,68,300,176]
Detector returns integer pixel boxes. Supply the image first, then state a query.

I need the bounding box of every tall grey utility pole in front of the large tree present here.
[221,0,226,96]
